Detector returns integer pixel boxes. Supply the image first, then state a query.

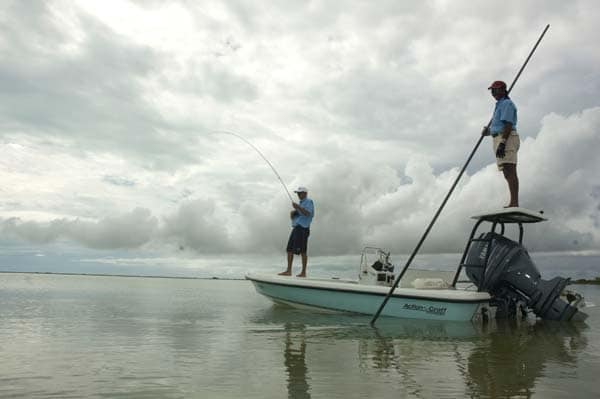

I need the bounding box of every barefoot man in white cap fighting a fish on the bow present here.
[279,186,315,277]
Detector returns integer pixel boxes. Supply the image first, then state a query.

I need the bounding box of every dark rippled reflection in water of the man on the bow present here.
[284,323,310,399]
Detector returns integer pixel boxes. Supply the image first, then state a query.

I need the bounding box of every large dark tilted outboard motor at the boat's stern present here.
[464,232,582,321]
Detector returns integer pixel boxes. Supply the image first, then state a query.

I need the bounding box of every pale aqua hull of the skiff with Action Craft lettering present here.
[246,274,490,321]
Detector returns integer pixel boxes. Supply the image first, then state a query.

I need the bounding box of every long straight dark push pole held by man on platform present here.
[371,24,550,326]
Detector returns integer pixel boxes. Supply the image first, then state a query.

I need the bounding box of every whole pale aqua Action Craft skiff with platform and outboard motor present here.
[246,207,587,321]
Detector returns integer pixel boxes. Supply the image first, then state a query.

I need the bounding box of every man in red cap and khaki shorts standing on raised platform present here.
[482,80,521,208]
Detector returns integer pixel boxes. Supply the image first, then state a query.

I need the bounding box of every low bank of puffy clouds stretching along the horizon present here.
[2,108,600,255]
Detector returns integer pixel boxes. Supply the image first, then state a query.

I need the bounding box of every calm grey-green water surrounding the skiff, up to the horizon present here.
[0,274,600,398]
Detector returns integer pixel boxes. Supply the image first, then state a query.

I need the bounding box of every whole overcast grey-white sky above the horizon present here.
[0,0,600,255]
